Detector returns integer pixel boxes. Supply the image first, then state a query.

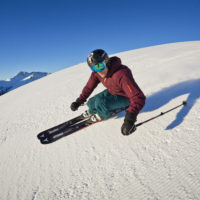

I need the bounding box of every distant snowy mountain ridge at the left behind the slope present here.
[0,71,49,96]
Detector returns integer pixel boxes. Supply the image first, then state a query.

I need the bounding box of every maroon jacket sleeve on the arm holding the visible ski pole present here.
[119,71,146,115]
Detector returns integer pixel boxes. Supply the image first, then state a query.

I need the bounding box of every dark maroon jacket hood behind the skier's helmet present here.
[106,56,122,77]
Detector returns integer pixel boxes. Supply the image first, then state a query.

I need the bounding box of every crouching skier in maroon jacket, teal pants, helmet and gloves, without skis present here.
[71,49,145,135]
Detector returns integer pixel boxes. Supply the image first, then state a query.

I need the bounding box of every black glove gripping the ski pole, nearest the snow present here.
[121,112,136,135]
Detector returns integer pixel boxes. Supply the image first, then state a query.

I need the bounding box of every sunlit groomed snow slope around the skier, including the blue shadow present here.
[0,41,200,200]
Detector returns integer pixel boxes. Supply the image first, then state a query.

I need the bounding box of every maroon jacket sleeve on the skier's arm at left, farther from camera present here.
[79,72,100,102]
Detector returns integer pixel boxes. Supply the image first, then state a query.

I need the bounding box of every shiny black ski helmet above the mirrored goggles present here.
[87,49,109,67]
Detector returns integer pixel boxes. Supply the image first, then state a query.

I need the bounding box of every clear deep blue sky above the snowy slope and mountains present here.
[0,0,200,80]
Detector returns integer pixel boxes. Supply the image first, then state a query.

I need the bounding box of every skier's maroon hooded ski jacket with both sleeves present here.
[79,57,146,115]
